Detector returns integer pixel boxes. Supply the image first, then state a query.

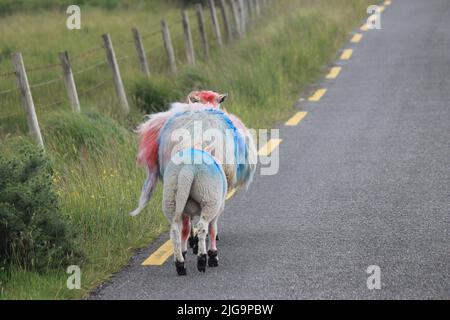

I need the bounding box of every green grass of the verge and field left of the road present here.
[0,0,369,299]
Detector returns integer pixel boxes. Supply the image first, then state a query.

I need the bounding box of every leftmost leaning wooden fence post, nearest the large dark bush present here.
[12,52,44,149]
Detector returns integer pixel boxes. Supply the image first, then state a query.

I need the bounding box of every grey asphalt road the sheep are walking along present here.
[91,0,450,299]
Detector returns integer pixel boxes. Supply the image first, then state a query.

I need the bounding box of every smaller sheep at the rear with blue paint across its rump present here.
[163,148,227,276]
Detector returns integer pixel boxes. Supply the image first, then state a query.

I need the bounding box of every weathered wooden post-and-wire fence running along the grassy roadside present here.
[0,0,270,147]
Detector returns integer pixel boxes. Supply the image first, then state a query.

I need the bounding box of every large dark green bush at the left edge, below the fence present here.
[0,139,80,272]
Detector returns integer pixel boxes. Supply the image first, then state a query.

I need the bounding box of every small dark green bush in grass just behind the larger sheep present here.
[132,80,181,114]
